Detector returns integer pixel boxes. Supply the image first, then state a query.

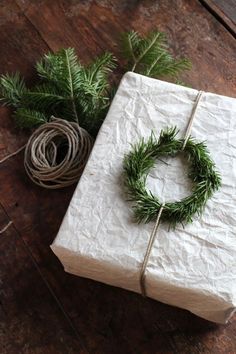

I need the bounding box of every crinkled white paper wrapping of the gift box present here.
[51,73,236,323]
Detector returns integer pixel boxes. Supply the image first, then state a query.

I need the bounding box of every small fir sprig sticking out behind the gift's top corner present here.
[121,31,191,78]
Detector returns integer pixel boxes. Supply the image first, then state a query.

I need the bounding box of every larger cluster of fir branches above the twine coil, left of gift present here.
[0,48,116,135]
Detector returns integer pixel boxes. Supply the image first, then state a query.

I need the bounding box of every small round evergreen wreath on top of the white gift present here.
[124,127,221,227]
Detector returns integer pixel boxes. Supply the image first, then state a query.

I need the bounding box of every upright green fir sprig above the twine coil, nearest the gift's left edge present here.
[36,48,115,131]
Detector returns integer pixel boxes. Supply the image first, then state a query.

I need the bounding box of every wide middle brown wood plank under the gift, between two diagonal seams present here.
[0,0,236,354]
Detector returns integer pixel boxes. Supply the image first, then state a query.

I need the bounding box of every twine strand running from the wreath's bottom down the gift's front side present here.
[139,204,165,296]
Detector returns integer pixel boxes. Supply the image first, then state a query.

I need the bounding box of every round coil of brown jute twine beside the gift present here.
[24,117,93,189]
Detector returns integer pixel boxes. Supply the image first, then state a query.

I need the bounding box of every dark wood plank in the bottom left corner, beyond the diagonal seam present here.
[0,203,85,354]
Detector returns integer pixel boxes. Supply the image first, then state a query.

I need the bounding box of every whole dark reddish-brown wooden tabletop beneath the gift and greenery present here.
[0,0,236,354]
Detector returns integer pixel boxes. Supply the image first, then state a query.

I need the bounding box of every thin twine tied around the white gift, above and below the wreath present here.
[139,91,203,297]
